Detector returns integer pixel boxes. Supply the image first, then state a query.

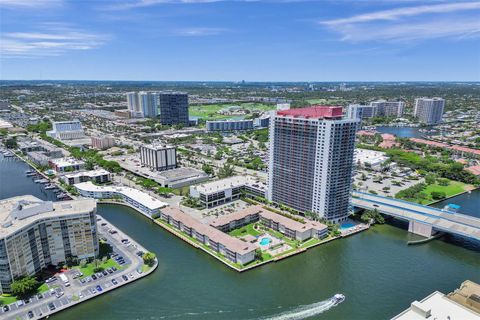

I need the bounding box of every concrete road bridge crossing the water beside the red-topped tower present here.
[352,191,480,241]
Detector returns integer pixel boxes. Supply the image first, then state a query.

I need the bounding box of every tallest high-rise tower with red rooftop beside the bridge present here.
[267,106,360,222]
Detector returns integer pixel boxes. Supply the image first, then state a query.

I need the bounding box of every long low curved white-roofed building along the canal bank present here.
[74,181,167,218]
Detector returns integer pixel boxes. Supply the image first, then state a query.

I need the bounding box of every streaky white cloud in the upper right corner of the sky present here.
[319,2,480,42]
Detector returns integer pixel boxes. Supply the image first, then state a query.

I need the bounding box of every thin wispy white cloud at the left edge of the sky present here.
[0,25,109,58]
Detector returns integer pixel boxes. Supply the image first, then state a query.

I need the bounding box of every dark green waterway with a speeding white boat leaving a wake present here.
[0,154,480,320]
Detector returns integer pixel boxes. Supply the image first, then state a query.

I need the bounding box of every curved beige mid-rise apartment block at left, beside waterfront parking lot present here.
[0,195,99,293]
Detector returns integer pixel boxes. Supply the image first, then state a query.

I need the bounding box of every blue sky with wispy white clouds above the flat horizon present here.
[0,0,480,81]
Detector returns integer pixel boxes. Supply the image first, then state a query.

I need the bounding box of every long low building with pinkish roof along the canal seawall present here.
[160,206,256,265]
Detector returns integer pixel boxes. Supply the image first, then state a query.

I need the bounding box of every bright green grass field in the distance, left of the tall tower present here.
[188,102,275,120]
